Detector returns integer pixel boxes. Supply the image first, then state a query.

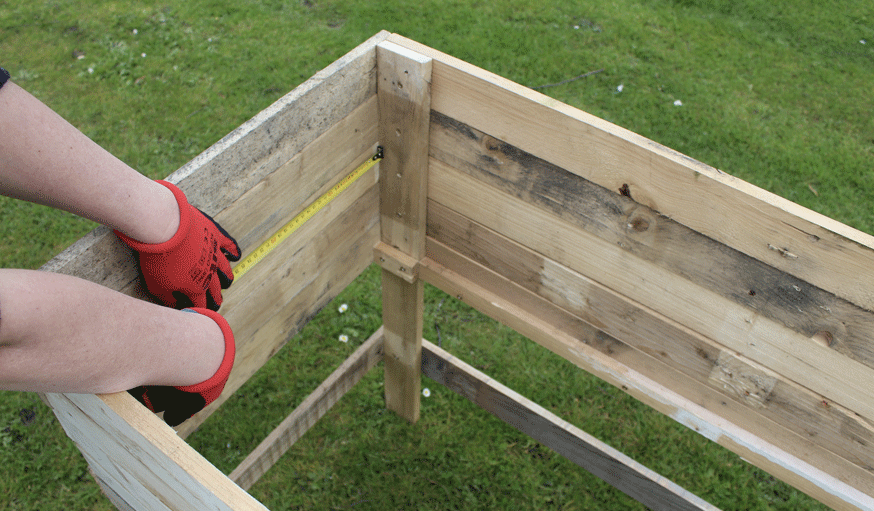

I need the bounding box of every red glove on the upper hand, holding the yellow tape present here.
[115,181,240,311]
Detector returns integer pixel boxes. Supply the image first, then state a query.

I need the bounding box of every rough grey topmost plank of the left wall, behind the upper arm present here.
[42,31,389,298]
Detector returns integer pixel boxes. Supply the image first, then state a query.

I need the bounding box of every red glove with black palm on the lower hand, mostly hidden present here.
[128,308,235,426]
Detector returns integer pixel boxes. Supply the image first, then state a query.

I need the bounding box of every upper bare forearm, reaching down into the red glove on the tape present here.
[0,82,179,243]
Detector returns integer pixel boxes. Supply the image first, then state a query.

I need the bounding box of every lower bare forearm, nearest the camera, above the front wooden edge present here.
[0,270,224,393]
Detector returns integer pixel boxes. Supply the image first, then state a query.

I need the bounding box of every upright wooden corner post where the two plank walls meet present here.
[375,41,431,422]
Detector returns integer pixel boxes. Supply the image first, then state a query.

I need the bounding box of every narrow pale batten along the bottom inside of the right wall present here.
[419,257,874,509]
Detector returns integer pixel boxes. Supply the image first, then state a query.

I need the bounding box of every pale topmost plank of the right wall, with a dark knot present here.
[389,34,874,310]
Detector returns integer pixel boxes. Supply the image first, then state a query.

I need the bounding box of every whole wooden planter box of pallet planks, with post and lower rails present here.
[45,32,874,510]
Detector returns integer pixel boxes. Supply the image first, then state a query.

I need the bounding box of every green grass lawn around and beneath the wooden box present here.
[0,0,874,510]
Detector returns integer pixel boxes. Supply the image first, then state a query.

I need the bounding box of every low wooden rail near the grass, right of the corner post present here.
[422,341,717,511]
